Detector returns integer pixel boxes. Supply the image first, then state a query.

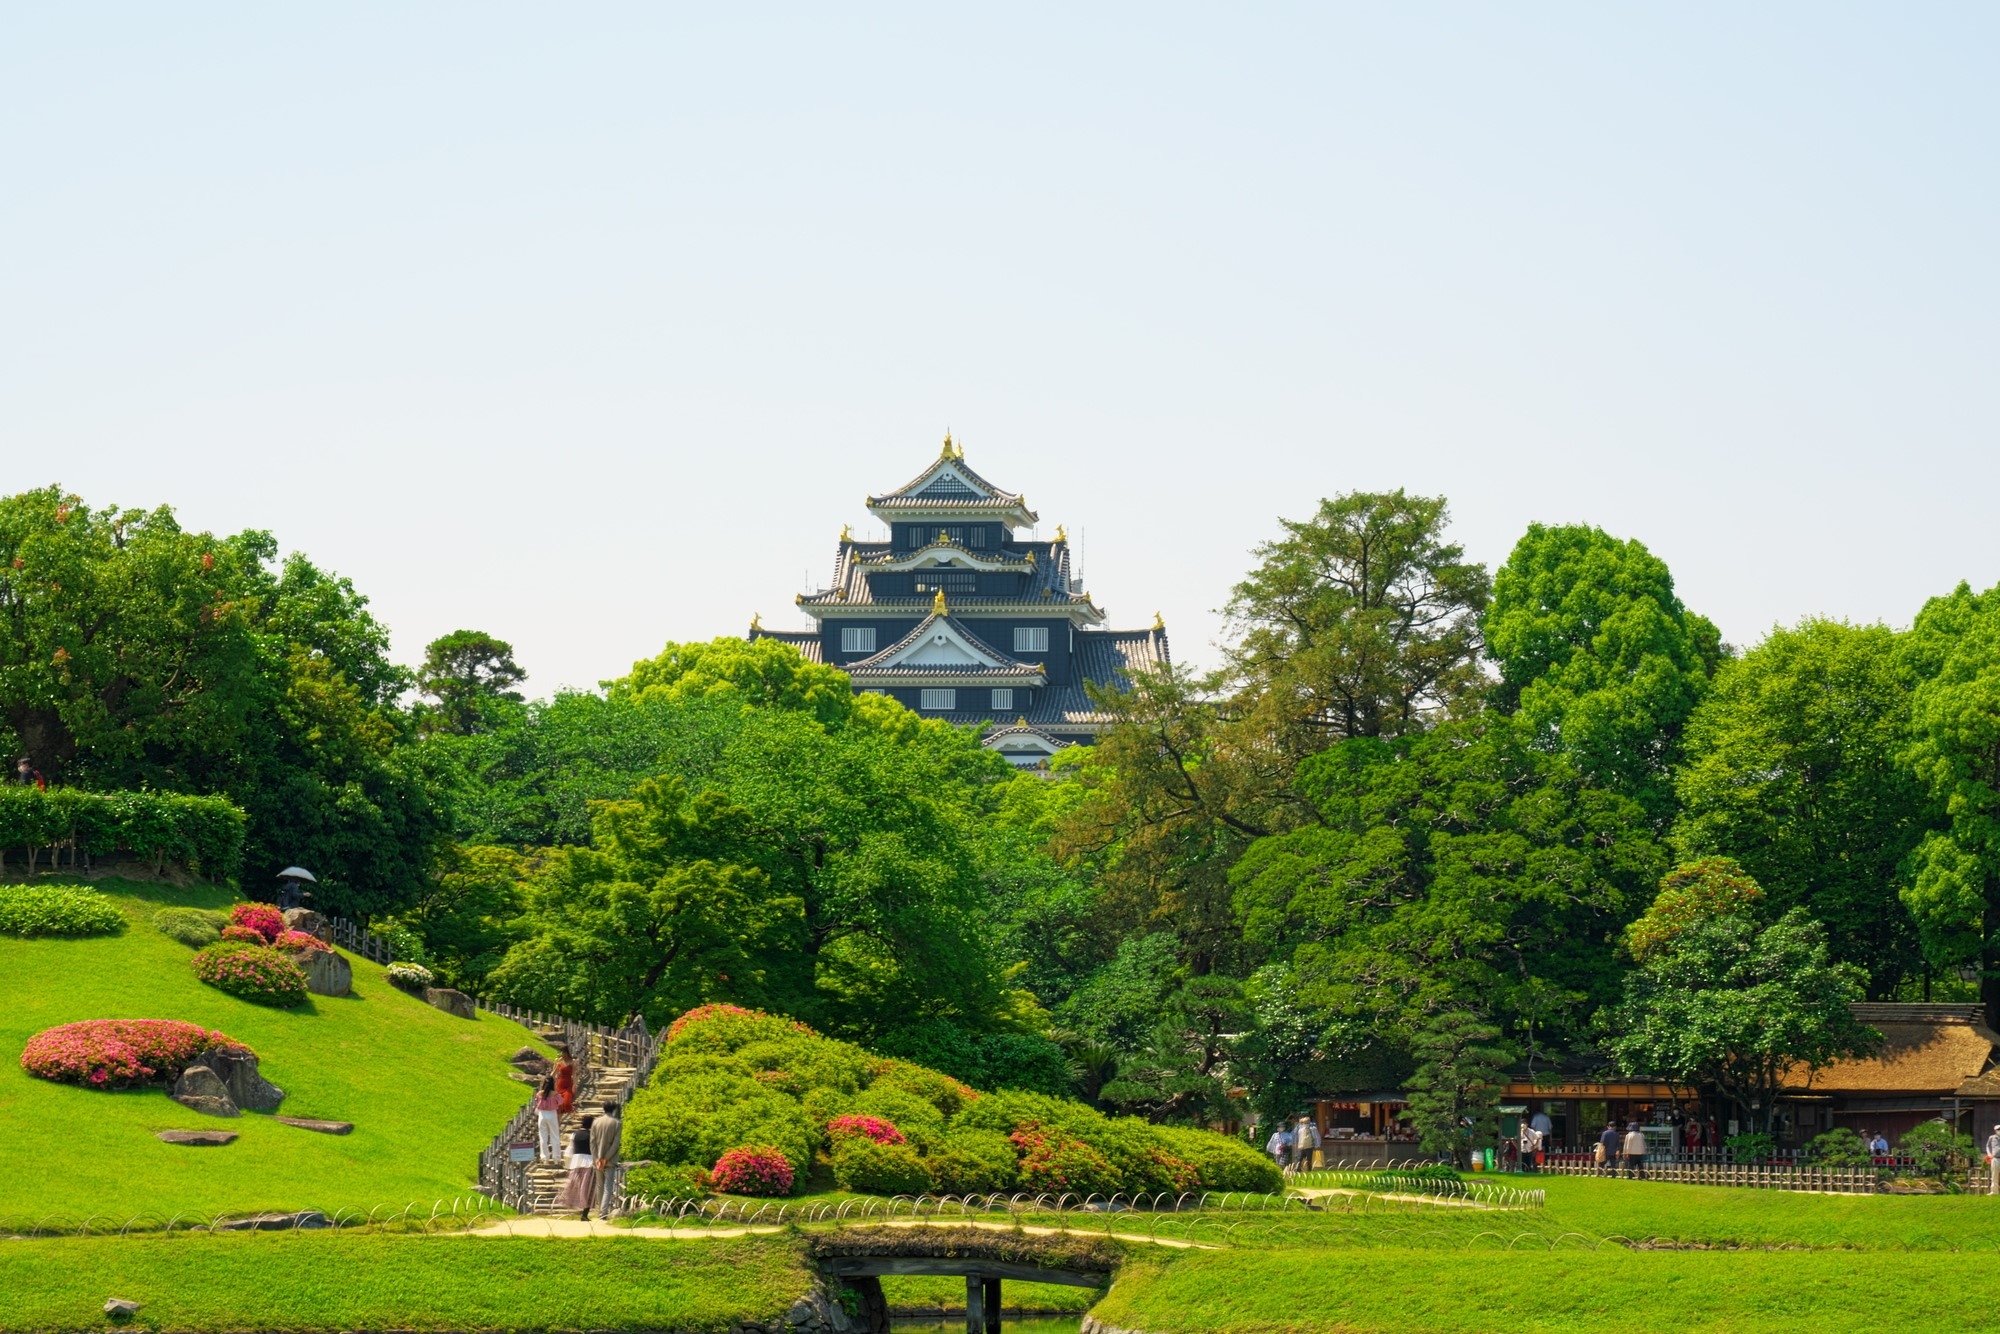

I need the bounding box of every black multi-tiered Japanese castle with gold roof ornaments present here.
[750,436,1168,766]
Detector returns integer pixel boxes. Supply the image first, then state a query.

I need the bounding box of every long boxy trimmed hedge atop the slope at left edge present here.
[0,788,244,880]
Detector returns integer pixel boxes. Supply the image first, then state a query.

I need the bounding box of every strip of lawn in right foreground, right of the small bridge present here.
[1096,1248,2000,1334]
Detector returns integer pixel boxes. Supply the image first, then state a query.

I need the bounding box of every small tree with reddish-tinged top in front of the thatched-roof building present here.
[1604,858,1880,1134]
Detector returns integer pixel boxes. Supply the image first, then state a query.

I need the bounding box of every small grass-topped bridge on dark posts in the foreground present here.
[810,1226,1124,1334]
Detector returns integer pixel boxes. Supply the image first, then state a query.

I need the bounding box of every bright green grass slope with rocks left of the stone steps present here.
[0,880,548,1218]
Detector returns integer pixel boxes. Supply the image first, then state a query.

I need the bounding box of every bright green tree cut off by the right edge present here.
[1904,584,2000,1024]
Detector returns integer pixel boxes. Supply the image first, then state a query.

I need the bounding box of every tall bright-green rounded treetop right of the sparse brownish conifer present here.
[1484,524,1724,830]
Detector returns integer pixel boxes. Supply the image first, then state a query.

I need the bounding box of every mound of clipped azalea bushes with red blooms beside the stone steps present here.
[624,1006,1284,1196]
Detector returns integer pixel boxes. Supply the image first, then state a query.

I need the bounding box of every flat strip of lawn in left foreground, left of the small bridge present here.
[0,1232,810,1334]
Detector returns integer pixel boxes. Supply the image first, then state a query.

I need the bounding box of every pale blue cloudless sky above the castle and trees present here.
[0,10,2000,694]
